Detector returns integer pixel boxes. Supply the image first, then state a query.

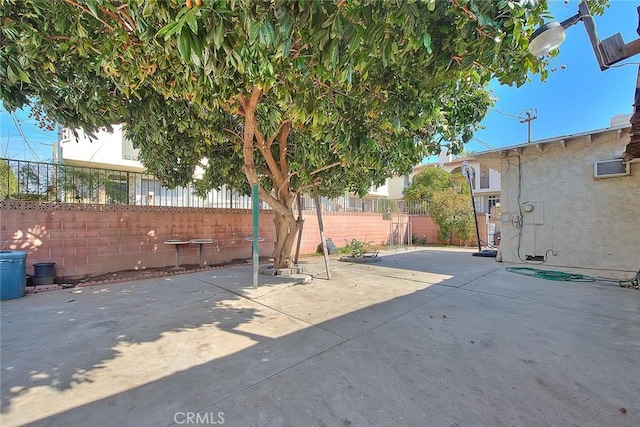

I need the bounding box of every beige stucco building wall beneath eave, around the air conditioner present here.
[501,128,640,277]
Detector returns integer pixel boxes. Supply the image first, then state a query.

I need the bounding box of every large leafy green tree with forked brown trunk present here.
[0,0,602,266]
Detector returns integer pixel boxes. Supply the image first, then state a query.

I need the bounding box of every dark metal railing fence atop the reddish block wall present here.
[0,158,428,214]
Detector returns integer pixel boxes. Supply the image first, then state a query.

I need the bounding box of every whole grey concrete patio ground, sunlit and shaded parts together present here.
[0,248,640,426]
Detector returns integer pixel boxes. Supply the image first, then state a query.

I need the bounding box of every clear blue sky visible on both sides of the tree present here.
[0,0,640,161]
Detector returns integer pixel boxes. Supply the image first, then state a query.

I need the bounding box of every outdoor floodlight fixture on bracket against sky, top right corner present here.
[529,0,640,71]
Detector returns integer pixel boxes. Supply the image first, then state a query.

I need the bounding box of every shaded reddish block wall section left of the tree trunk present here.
[0,205,274,278]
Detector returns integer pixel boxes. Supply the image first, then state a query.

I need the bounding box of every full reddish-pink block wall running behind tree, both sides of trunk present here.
[0,200,482,279]
